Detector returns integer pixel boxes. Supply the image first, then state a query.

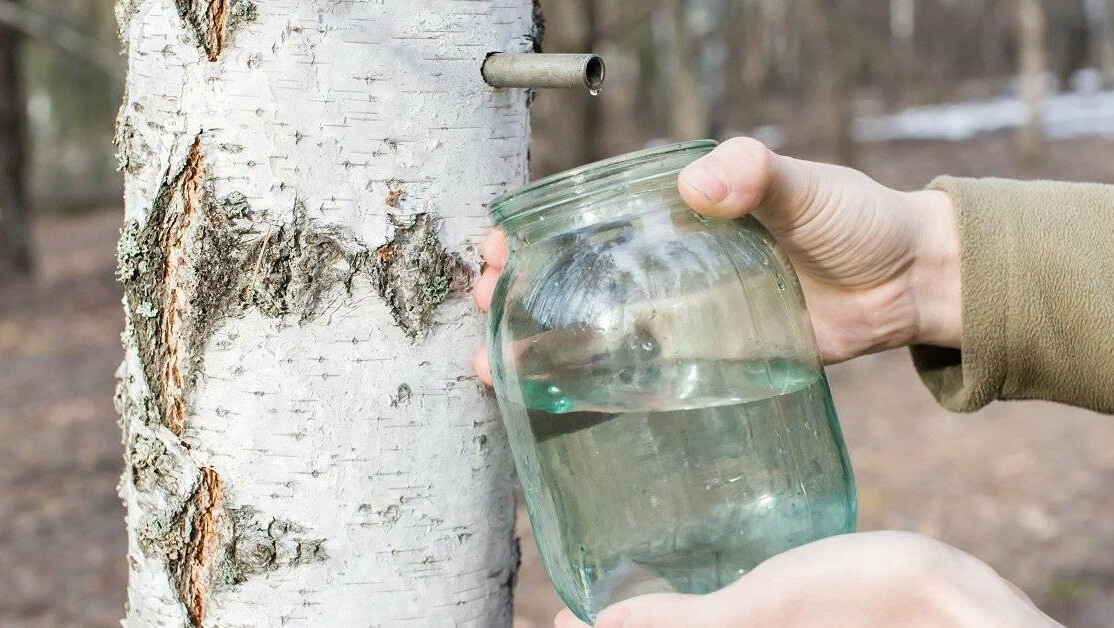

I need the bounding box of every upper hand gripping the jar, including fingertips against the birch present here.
[473,138,961,382]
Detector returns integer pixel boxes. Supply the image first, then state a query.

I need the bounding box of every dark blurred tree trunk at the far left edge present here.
[0,0,31,279]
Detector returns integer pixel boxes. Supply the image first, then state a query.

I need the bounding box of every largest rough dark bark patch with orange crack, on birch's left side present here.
[117,136,368,435]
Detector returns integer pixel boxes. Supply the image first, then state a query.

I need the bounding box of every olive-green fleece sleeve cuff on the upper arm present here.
[912,177,1114,413]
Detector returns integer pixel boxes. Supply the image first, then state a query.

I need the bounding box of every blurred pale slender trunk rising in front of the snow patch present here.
[1016,0,1047,161]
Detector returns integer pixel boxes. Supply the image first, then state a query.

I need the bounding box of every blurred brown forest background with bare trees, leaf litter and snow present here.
[0,0,1114,628]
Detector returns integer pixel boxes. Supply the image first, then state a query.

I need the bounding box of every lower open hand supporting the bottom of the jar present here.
[554,532,1059,628]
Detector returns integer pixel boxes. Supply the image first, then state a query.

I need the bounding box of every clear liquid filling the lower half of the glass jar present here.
[505,361,856,621]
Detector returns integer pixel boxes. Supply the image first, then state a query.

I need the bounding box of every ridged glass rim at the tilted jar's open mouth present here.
[489,139,717,225]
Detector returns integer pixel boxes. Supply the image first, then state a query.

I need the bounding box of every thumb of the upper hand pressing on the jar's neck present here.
[677,137,774,218]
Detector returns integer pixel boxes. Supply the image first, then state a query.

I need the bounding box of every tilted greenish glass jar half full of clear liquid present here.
[489,141,856,622]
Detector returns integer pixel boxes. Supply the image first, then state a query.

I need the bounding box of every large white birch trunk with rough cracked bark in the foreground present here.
[117,0,535,627]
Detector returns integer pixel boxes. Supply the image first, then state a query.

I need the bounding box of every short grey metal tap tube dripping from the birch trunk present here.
[480,52,605,92]
